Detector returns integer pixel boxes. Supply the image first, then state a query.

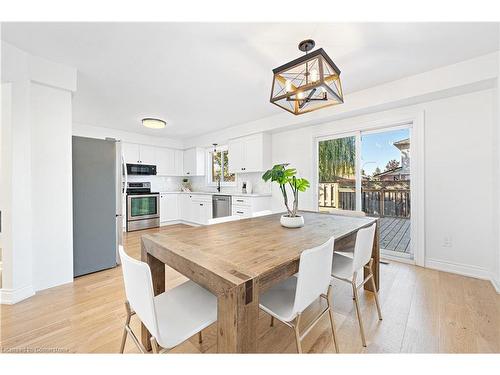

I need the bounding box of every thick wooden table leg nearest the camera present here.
[217,279,259,353]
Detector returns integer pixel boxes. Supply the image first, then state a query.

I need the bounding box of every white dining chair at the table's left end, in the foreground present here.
[119,246,217,353]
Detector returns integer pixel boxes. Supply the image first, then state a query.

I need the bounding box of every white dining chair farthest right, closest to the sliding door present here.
[332,223,382,346]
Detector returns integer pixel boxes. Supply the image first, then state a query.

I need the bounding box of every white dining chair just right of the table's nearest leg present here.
[260,237,339,353]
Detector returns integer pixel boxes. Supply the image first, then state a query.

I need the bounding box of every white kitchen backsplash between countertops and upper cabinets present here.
[128,172,271,194]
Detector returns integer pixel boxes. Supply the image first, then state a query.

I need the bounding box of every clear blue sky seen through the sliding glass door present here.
[361,129,410,175]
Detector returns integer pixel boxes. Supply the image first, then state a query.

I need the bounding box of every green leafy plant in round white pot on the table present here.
[262,164,309,228]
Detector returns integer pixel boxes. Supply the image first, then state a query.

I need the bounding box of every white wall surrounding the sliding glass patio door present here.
[272,89,498,284]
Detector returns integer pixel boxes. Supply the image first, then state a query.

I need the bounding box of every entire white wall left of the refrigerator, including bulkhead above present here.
[0,42,76,303]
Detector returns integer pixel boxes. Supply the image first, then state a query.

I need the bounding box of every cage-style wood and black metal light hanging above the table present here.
[271,39,344,115]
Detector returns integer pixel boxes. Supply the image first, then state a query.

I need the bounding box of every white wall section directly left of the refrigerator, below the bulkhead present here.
[30,83,73,290]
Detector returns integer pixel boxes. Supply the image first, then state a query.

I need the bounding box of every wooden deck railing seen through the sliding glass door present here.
[318,182,411,218]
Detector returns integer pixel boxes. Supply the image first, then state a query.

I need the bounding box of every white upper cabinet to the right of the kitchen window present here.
[228,133,271,173]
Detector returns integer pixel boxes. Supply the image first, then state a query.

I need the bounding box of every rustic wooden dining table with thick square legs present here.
[141,212,380,353]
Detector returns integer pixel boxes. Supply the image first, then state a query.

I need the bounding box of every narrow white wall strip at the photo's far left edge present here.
[0,43,34,303]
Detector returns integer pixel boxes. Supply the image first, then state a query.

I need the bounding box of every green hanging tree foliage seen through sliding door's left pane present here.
[319,137,356,182]
